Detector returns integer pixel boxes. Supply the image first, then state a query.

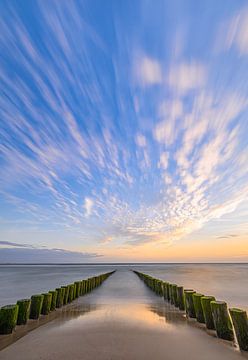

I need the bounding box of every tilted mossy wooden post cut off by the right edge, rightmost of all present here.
[229,308,248,351]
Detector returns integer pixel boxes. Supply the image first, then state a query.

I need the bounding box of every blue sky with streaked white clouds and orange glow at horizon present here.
[0,0,248,262]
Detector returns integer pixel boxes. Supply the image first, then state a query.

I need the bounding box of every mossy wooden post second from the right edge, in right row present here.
[210,301,234,341]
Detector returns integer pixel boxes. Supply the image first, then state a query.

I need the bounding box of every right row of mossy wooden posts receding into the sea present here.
[134,271,248,351]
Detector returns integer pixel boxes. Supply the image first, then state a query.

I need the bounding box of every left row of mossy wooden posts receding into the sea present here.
[0,271,114,334]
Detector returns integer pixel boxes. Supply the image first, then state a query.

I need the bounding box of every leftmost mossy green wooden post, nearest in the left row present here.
[0,305,18,334]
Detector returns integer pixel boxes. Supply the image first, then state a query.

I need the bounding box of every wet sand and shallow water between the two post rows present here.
[0,271,248,360]
